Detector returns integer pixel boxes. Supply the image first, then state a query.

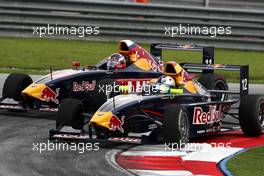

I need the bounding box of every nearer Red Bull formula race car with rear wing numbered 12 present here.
[50,45,264,146]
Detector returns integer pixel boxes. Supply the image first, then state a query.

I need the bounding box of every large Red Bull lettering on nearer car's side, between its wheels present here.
[193,105,222,125]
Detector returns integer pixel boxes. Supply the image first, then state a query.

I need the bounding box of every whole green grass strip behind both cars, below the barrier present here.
[0,37,264,83]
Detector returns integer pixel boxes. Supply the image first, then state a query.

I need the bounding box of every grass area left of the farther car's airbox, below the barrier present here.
[0,38,118,70]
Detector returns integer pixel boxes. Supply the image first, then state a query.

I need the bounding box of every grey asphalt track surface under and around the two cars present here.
[0,75,264,176]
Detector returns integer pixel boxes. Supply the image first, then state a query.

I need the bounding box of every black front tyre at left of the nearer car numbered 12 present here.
[56,98,84,130]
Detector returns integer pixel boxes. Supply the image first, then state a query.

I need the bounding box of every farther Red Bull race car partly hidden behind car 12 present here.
[0,40,163,111]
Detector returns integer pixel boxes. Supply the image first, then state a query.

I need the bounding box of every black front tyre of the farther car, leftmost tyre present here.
[2,73,33,101]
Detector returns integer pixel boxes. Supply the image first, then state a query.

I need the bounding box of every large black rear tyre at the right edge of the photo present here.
[239,95,264,136]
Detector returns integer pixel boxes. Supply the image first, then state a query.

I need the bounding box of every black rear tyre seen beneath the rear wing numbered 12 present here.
[198,73,228,101]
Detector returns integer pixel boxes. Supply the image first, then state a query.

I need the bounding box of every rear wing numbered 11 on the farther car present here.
[150,43,214,65]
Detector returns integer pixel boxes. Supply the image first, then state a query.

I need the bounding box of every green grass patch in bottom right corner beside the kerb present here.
[227,147,264,176]
